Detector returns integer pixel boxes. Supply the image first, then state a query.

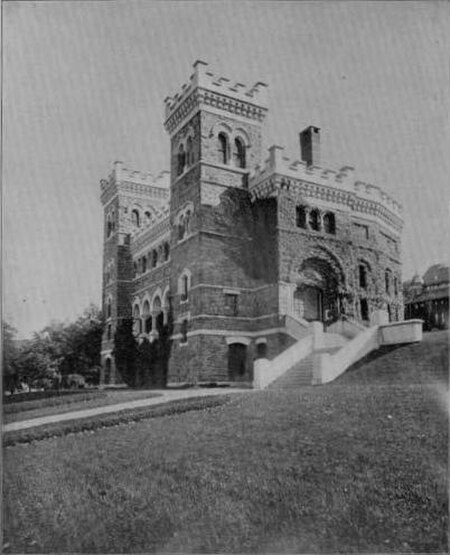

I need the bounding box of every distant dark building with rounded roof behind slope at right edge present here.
[403,264,450,330]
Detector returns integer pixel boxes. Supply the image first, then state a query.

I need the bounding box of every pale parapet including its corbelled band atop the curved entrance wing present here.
[249,145,403,230]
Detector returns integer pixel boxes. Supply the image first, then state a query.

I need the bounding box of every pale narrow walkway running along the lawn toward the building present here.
[2,388,252,432]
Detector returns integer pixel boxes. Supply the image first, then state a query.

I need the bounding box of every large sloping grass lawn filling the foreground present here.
[3,334,448,553]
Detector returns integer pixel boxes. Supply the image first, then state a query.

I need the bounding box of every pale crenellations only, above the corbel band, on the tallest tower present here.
[164,60,268,132]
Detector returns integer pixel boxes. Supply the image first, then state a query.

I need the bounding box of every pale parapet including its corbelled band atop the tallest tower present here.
[164,60,268,134]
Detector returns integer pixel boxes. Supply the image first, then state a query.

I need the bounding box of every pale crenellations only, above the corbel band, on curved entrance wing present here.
[250,145,402,218]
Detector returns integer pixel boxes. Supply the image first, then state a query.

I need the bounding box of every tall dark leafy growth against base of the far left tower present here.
[113,318,138,387]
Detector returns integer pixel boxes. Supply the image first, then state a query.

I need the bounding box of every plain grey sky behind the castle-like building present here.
[2,0,450,336]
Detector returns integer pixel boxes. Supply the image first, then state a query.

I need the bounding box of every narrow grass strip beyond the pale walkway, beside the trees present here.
[3,389,159,424]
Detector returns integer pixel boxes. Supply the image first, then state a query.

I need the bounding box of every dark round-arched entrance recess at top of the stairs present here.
[294,258,342,322]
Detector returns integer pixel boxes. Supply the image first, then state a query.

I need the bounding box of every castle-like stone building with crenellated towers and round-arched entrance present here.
[101,61,403,383]
